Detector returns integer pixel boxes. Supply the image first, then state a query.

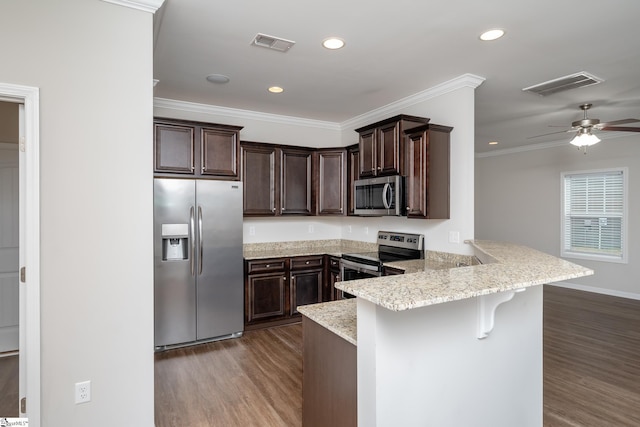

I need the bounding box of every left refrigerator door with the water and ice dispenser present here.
[153,178,197,347]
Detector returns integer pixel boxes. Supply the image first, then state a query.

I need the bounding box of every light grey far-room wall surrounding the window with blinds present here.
[475,134,640,298]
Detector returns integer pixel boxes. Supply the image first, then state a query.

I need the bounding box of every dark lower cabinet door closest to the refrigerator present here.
[245,272,287,323]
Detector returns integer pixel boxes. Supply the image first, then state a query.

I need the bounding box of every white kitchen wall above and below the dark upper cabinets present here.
[154,80,474,254]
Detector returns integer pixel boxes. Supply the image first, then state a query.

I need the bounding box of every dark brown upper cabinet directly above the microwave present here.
[356,114,429,178]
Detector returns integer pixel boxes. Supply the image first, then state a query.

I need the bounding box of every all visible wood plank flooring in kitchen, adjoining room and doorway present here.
[0,286,640,427]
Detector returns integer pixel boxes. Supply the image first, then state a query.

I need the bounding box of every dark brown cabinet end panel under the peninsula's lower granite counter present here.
[302,316,358,427]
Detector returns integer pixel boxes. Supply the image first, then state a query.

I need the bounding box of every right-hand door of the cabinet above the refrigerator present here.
[200,128,240,180]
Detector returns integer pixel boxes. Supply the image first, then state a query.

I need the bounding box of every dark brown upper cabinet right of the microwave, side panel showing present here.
[405,124,453,219]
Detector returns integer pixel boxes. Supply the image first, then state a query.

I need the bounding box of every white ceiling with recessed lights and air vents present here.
[154,0,640,153]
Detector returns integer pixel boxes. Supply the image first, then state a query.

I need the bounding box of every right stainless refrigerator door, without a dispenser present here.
[196,180,244,340]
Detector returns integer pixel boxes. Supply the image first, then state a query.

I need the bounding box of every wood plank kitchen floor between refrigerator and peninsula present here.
[155,323,302,427]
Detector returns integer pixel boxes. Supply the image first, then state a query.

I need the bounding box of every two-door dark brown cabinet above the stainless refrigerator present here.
[153,118,242,181]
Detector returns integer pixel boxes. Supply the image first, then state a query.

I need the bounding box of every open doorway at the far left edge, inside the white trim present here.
[0,101,20,417]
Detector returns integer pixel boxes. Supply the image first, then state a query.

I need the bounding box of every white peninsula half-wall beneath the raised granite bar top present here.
[357,286,542,427]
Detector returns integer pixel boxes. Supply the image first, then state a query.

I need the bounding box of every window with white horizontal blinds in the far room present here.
[561,168,627,263]
